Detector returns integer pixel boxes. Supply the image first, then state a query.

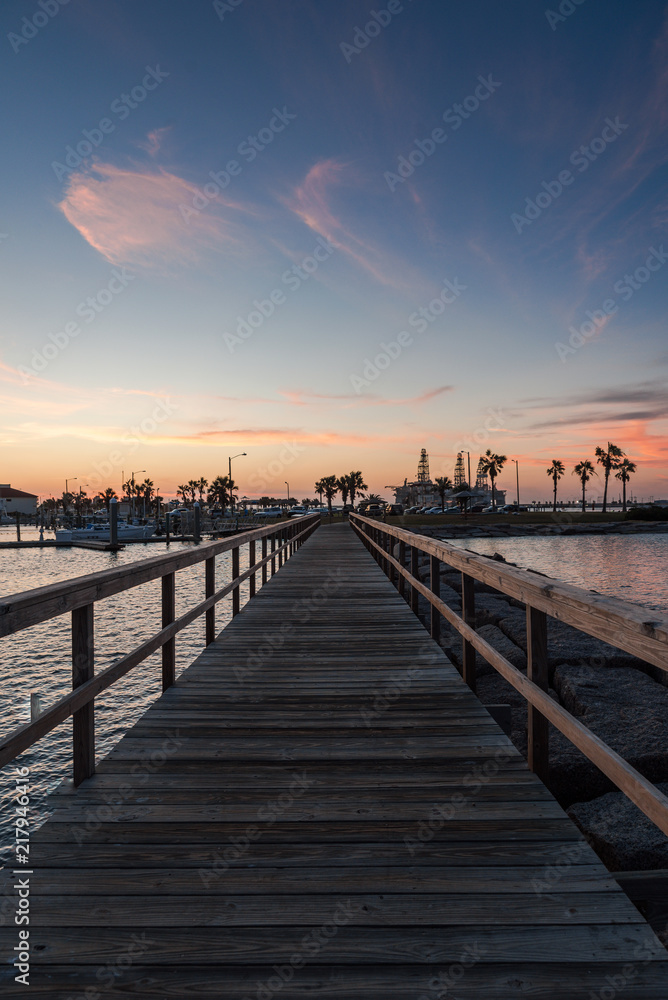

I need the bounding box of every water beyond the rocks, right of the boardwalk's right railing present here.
[450,532,668,612]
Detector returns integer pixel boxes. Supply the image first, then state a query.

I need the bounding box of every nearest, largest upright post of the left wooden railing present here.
[72,604,95,786]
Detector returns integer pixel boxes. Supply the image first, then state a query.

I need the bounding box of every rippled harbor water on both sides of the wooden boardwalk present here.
[0,528,668,864]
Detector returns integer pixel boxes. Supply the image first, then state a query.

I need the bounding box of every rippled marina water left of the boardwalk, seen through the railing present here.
[0,527,248,864]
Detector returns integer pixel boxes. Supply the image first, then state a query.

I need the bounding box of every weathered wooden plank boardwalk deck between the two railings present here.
[0,524,668,1000]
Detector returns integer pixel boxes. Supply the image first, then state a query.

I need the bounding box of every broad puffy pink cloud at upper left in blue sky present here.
[58,163,254,271]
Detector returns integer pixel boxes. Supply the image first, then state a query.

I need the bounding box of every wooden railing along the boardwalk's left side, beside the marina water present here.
[0,514,320,785]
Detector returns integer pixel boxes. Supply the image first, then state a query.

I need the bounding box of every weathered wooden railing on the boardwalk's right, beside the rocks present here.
[350,514,668,834]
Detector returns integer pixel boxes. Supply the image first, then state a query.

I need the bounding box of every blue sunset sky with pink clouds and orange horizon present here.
[0,0,668,501]
